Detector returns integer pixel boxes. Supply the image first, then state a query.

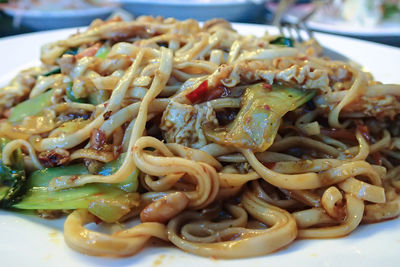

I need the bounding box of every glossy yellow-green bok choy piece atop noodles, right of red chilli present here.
[204,83,315,152]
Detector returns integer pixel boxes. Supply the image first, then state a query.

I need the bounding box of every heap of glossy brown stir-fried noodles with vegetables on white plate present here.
[0,17,400,258]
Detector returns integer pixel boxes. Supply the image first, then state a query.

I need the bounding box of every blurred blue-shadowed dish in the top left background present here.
[3,6,115,31]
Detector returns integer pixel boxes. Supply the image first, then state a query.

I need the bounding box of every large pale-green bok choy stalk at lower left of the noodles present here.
[13,154,139,222]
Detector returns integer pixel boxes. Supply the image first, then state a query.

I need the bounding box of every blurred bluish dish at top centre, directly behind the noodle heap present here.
[117,0,264,22]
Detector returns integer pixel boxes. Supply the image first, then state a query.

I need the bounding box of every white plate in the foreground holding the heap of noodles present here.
[0,24,400,267]
